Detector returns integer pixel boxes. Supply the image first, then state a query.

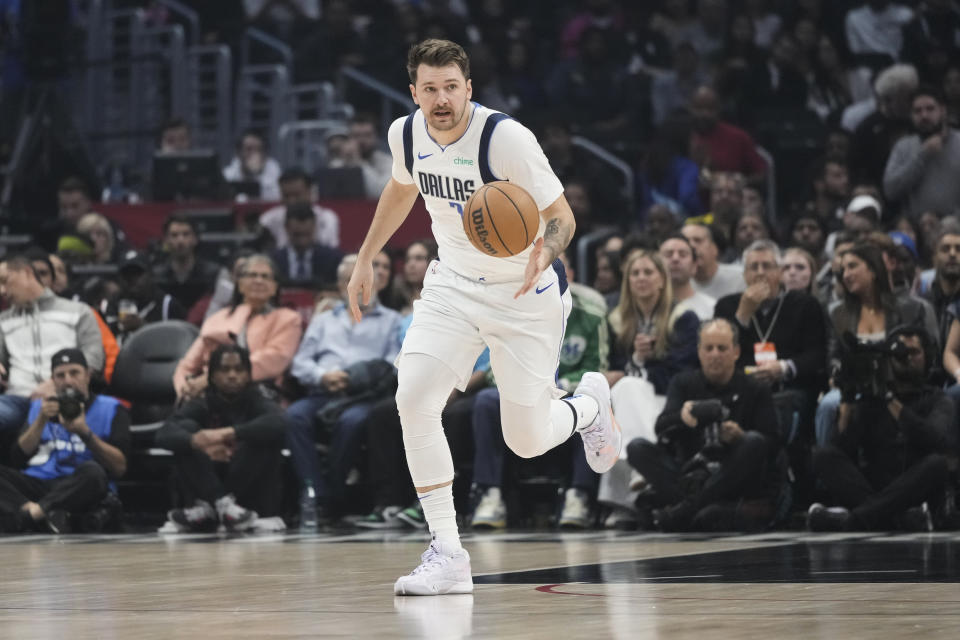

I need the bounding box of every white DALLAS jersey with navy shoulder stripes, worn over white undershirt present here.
[387,102,563,282]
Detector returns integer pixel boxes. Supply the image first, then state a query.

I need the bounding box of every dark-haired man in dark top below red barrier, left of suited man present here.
[153,214,220,311]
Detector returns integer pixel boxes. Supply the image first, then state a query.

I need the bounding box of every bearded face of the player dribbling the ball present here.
[410,63,473,131]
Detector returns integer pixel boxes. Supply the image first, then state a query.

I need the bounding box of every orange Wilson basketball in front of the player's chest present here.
[463,181,540,258]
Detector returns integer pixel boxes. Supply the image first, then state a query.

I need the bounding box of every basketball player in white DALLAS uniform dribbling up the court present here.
[347,39,621,595]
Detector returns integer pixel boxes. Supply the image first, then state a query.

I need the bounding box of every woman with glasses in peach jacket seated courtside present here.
[173,254,302,402]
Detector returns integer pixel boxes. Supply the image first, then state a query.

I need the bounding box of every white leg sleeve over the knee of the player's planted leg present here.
[396,353,456,487]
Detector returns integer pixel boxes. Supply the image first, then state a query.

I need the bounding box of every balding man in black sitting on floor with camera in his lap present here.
[627,318,779,531]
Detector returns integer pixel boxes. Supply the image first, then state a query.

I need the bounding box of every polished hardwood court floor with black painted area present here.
[0,533,960,640]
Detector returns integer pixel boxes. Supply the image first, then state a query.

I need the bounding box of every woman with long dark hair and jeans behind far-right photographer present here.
[816,243,927,446]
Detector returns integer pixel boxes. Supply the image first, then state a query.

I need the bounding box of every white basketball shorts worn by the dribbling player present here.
[397,260,573,406]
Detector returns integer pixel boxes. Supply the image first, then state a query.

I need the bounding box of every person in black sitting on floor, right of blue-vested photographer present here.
[156,344,284,531]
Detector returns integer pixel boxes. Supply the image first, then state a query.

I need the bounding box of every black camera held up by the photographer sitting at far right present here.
[834,332,908,402]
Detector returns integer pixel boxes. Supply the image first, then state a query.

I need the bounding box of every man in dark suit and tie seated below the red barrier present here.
[273,203,342,286]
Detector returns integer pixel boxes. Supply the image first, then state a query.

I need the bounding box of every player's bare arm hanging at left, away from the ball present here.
[347,178,420,322]
